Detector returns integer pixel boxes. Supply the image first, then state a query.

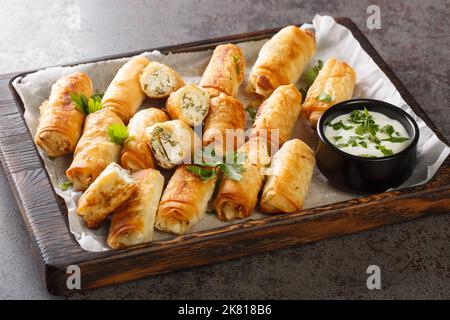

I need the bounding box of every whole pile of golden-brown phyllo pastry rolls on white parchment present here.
[35,26,356,248]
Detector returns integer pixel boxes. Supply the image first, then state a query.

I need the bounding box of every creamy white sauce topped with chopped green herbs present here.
[324,109,411,158]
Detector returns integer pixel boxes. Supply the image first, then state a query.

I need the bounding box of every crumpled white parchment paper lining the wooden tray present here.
[14,15,450,251]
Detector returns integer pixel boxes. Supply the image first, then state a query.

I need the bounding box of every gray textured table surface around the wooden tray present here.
[0,0,450,299]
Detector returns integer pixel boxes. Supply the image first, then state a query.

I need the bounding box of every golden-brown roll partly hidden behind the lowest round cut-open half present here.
[120,108,169,172]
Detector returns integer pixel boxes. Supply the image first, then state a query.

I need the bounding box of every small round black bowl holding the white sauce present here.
[316,99,419,192]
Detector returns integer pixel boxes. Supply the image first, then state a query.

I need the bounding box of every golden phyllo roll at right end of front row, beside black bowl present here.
[259,139,316,213]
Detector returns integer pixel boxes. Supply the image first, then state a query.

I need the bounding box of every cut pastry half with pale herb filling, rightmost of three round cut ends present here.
[166,84,210,127]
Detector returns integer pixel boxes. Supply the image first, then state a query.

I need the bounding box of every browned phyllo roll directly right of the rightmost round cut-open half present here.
[203,93,245,154]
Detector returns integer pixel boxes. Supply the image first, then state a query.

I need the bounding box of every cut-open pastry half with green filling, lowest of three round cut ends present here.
[145,120,199,169]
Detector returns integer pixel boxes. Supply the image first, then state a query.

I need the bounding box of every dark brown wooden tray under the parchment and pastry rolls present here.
[0,18,450,295]
